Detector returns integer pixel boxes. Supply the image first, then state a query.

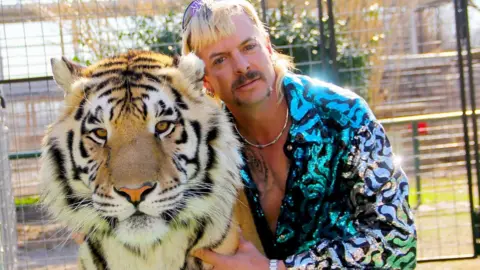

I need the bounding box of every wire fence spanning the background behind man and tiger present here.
[0,0,480,269]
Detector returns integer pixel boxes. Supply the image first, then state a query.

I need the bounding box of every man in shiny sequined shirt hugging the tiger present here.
[183,0,416,270]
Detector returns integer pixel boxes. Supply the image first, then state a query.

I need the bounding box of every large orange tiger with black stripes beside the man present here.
[40,50,258,270]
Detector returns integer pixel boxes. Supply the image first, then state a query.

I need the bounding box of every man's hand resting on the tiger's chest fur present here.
[192,237,287,270]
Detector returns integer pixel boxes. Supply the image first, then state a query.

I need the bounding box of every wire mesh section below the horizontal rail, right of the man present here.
[385,116,478,260]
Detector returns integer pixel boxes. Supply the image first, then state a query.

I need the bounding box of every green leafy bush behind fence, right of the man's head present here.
[268,1,370,98]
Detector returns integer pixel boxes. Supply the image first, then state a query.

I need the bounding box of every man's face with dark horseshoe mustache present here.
[198,14,275,106]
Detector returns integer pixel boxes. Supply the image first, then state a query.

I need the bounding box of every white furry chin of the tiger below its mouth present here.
[115,215,168,246]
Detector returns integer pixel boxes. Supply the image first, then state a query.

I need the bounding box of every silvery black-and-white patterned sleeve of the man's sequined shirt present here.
[285,121,417,269]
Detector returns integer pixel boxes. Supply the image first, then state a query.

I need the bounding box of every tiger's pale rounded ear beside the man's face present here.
[175,53,205,91]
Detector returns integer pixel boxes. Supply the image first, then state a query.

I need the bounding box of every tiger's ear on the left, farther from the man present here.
[50,56,85,94]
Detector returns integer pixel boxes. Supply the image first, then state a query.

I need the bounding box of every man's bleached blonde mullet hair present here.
[182,0,294,101]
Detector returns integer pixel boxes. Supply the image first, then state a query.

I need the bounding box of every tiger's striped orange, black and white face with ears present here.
[41,52,241,245]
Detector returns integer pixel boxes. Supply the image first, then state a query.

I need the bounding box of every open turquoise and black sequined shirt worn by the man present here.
[241,74,416,269]
